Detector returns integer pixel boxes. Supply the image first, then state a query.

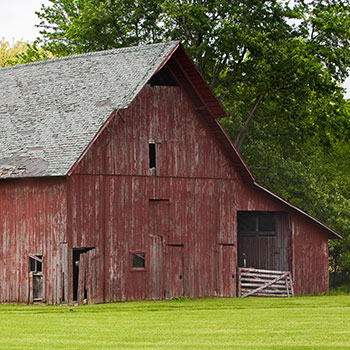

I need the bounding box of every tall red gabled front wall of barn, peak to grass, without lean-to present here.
[68,85,238,301]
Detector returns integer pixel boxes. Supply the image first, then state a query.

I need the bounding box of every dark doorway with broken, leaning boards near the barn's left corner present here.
[73,248,97,305]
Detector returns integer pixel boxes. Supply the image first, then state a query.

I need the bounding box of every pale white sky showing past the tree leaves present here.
[0,0,350,98]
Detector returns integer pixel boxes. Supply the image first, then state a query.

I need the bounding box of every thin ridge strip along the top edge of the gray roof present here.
[0,40,179,72]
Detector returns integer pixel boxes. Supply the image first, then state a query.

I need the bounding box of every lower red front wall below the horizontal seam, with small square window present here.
[70,175,236,302]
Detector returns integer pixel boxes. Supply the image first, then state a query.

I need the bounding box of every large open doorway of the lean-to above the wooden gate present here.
[237,211,291,271]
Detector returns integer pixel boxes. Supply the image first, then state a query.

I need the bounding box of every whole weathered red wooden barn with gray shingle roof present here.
[0,42,339,304]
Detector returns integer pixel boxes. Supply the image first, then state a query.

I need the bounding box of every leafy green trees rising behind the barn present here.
[37,0,350,288]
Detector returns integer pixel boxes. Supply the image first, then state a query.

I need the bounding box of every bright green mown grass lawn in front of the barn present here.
[0,296,350,350]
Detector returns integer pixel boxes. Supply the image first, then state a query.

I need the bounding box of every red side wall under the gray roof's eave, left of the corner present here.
[0,178,66,304]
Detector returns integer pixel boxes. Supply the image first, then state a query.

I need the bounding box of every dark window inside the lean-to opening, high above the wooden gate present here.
[238,211,276,236]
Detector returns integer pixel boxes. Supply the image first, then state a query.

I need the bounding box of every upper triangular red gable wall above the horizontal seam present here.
[75,85,237,179]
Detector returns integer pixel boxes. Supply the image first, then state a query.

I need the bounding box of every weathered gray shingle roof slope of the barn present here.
[0,42,177,178]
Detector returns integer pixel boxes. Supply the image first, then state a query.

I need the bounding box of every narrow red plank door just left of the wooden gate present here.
[215,244,236,297]
